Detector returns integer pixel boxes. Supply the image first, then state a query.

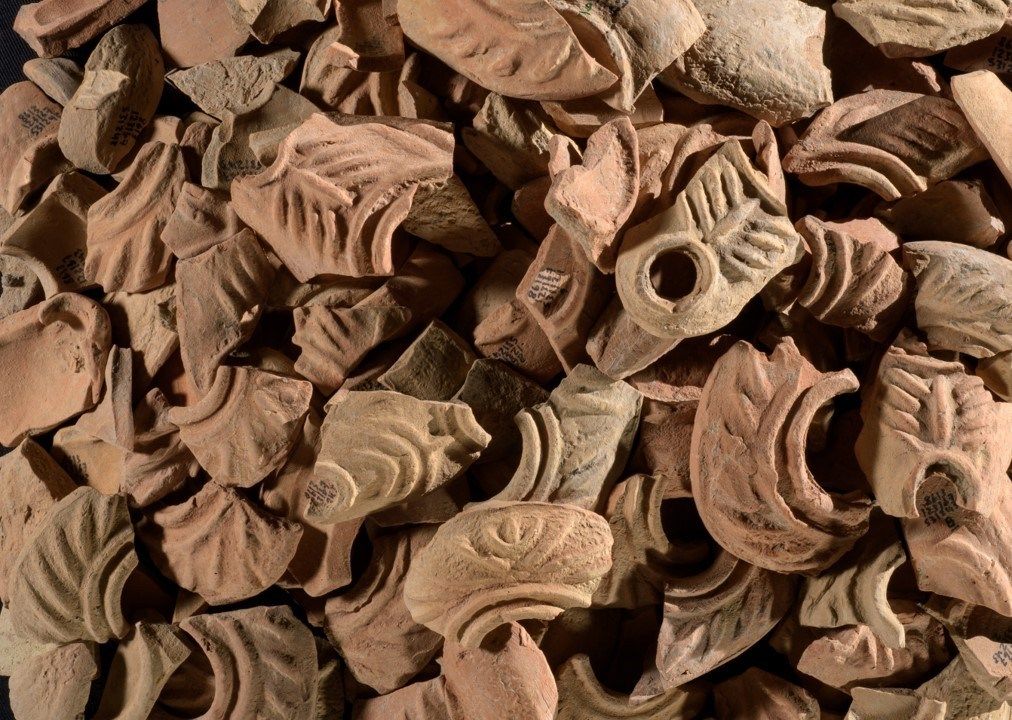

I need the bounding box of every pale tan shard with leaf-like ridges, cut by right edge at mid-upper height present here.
[903,240,1012,357]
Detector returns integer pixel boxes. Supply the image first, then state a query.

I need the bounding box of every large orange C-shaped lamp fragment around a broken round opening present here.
[689,338,870,574]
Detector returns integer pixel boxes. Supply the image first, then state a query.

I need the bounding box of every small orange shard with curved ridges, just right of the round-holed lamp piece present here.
[797,216,913,342]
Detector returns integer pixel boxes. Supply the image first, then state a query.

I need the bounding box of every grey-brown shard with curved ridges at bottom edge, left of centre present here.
[174,606,317,720]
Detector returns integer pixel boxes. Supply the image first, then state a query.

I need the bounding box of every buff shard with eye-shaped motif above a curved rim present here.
[404,502,611,647]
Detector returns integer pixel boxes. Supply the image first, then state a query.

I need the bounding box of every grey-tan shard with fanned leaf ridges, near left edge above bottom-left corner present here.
[10,487,138,643]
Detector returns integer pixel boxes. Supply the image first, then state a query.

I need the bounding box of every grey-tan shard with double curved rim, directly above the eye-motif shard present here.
[496,366,643,510]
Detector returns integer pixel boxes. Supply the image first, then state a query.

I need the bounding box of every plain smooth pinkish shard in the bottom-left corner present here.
[10,642,98,720]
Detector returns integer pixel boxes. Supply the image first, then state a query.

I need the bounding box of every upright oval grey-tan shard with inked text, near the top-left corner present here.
[59,25,165,174]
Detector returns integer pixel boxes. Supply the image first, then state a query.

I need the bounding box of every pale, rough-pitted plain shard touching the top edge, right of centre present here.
[661,0,833,128]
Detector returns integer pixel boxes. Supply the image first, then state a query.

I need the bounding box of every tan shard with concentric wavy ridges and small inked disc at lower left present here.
[305,390,491,523]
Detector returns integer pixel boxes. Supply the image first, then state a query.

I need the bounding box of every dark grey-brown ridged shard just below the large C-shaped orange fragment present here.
[657,551,794,688]
